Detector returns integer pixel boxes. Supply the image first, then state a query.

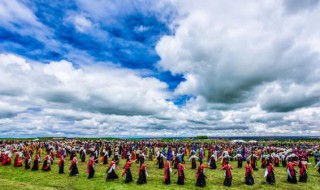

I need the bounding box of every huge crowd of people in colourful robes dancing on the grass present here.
[0,140,320,187]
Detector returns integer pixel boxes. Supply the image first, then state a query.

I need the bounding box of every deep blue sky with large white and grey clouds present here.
[0,0,320,136]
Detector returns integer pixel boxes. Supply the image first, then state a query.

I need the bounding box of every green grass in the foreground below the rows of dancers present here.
[0,153,320,190]
